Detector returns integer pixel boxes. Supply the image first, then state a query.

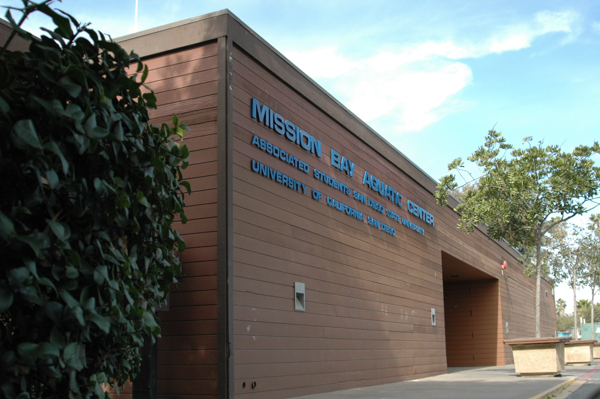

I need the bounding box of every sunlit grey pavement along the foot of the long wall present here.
[298,361,600,399]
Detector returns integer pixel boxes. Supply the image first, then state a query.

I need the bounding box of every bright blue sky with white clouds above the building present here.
[0,0,600,312]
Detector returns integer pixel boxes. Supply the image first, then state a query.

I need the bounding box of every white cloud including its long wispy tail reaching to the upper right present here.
[285,11,578,132]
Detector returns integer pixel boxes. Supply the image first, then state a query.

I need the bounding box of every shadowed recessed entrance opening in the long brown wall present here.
[442,252,504,367]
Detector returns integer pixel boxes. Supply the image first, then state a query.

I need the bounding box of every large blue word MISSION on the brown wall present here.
[251,98,321,158]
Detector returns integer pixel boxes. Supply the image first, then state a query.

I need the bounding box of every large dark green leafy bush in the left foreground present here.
[0,0,189,399]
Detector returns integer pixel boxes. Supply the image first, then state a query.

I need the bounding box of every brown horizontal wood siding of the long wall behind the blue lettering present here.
[231,41,552,398]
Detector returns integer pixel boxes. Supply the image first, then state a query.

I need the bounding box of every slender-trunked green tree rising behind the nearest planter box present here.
[435,130,600,337]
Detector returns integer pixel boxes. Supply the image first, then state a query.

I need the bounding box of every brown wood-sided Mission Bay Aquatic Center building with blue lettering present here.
[118,11,556,399]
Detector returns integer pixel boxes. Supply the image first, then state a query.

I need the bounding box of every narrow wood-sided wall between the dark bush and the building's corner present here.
[145,42,218,399]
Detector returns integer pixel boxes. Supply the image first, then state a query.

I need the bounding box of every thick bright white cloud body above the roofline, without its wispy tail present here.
[286,43,472,131]
